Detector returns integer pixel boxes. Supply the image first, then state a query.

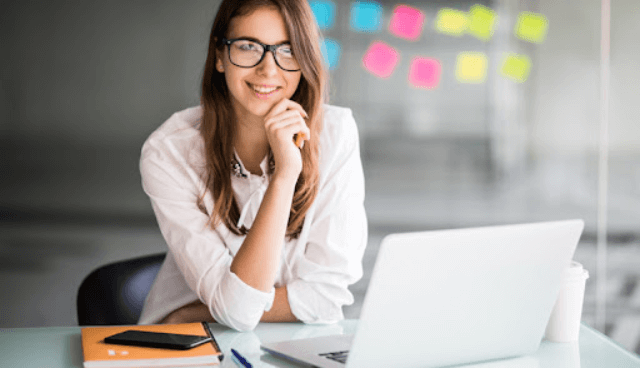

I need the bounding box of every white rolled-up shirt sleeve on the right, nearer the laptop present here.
[287,109,367,323]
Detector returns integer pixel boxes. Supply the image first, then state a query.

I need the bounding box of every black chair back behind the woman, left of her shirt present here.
[76,253,166,326]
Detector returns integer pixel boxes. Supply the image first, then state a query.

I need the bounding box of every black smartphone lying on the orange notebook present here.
[104,330,211,350]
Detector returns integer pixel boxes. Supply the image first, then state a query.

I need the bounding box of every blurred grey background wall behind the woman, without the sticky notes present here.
[0,0,640,351]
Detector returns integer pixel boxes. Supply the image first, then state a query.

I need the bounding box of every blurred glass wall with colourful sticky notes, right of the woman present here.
[320,0,640,351]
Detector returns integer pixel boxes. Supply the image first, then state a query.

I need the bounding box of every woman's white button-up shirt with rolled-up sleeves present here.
[139,105,367,331]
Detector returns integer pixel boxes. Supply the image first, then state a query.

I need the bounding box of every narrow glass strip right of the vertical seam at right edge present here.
[599,0,640,353]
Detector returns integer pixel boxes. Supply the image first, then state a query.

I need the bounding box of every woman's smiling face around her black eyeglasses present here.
[216,7,301,121]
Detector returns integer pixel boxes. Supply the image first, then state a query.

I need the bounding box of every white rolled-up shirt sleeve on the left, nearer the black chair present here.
[140,137,274,331]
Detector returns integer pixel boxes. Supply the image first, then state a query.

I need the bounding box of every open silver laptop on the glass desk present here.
[261,220,584,368]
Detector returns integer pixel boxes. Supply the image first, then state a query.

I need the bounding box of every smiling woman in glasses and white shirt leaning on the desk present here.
[139,0,367,331]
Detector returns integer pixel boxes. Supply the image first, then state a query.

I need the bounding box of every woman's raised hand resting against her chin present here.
[264,99,311,180]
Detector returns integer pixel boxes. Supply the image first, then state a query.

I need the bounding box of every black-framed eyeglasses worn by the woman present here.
[222,38,300,72]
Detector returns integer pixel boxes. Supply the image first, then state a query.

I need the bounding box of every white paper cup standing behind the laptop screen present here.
[545,261,589,342]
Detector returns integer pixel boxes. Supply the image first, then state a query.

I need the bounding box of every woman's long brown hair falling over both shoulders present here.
[198,0,327,238]
